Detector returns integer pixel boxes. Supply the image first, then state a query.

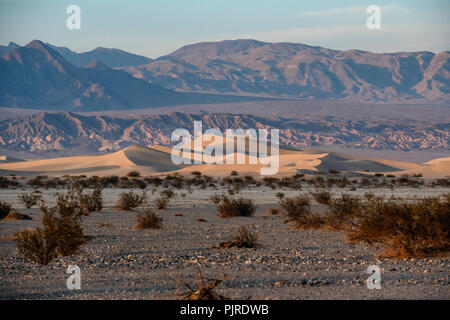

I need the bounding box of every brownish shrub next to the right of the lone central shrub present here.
[279,195,322,229]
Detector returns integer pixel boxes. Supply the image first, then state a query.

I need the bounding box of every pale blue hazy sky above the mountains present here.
[0,0,450,58]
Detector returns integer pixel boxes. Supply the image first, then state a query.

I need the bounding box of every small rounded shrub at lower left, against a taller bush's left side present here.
[16,228,57,265]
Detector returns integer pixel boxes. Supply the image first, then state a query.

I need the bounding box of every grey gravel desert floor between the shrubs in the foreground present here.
[0,187,450,299]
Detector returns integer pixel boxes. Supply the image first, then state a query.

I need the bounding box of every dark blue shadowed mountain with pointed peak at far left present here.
[0,40,260,111]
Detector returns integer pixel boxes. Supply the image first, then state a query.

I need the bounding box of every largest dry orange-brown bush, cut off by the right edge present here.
[347,196,450,258]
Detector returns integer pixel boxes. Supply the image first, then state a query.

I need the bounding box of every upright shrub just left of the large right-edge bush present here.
[326,193,361,230]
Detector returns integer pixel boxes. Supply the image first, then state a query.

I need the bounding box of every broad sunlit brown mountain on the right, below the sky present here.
[124,40,450,102]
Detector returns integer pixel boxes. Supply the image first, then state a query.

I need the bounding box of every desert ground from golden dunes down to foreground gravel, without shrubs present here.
[0,146,450,299]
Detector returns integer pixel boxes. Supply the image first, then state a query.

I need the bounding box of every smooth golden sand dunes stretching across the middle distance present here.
[0,146,450,178]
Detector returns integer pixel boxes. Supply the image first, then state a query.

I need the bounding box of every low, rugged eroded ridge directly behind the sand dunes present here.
[0,112,450,153]
